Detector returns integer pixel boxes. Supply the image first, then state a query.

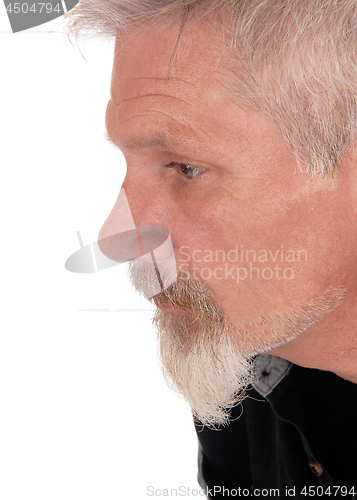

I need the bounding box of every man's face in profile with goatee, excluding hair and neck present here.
[100,15,353,423]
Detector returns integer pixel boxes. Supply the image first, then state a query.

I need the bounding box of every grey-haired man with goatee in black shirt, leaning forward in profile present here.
[65,0,357,498]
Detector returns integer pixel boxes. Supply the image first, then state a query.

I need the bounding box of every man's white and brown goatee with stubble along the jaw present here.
[129,262,343,427]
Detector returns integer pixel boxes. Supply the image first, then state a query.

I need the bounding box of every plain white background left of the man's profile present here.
[0,3,202,500]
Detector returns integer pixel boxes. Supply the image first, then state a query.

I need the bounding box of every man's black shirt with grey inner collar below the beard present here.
[196,354,357,500]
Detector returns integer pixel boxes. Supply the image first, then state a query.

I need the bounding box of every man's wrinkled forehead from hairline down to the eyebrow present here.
[106,16,281,168]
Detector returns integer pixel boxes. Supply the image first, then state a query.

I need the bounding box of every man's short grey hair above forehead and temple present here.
[67,0,357,174]
